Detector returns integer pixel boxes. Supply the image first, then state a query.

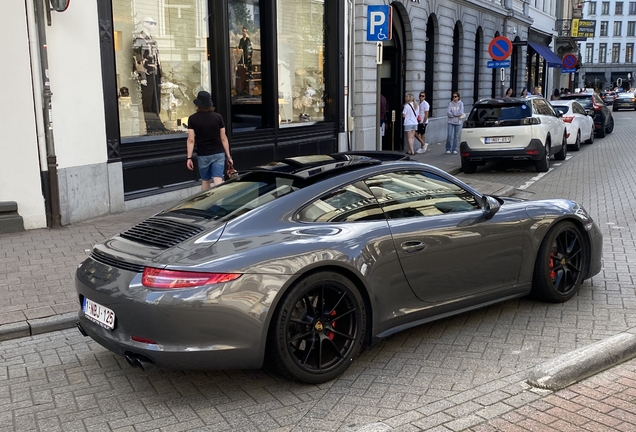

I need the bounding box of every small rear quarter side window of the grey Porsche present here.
[297,182,386,222]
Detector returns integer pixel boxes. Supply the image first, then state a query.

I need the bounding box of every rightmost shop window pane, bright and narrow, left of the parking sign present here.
[276,0,325,125]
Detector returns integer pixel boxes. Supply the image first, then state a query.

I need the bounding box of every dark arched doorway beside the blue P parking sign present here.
[380,6,406,151]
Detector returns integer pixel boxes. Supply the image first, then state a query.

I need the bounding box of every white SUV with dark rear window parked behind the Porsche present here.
[459,97,567,173]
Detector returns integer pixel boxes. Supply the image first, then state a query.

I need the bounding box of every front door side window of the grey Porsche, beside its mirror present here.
[365,171,479,219]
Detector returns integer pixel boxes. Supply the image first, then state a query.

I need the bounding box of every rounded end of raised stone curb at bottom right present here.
[527,333,636,390]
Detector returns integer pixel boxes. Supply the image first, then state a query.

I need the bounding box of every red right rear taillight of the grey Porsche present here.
[141,267,241,289]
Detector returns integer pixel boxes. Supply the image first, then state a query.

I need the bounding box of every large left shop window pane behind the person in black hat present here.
[113,0,210,137]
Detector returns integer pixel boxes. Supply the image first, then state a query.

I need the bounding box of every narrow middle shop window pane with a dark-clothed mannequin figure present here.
[228,0,263,132]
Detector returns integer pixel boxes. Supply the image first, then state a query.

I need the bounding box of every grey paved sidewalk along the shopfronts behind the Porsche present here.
[0,148,514,340]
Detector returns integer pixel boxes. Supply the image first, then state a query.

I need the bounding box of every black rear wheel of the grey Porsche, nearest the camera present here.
[267,271,367,384]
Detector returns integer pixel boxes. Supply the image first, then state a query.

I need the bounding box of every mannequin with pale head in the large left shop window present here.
[133,17,166,133]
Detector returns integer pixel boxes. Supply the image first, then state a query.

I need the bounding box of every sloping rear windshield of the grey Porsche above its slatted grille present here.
[167,172,303,221]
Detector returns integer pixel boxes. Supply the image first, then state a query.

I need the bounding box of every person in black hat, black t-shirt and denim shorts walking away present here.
[186,91,234,191]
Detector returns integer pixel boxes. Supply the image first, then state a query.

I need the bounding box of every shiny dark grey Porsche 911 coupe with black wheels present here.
[76,153,602,383]
